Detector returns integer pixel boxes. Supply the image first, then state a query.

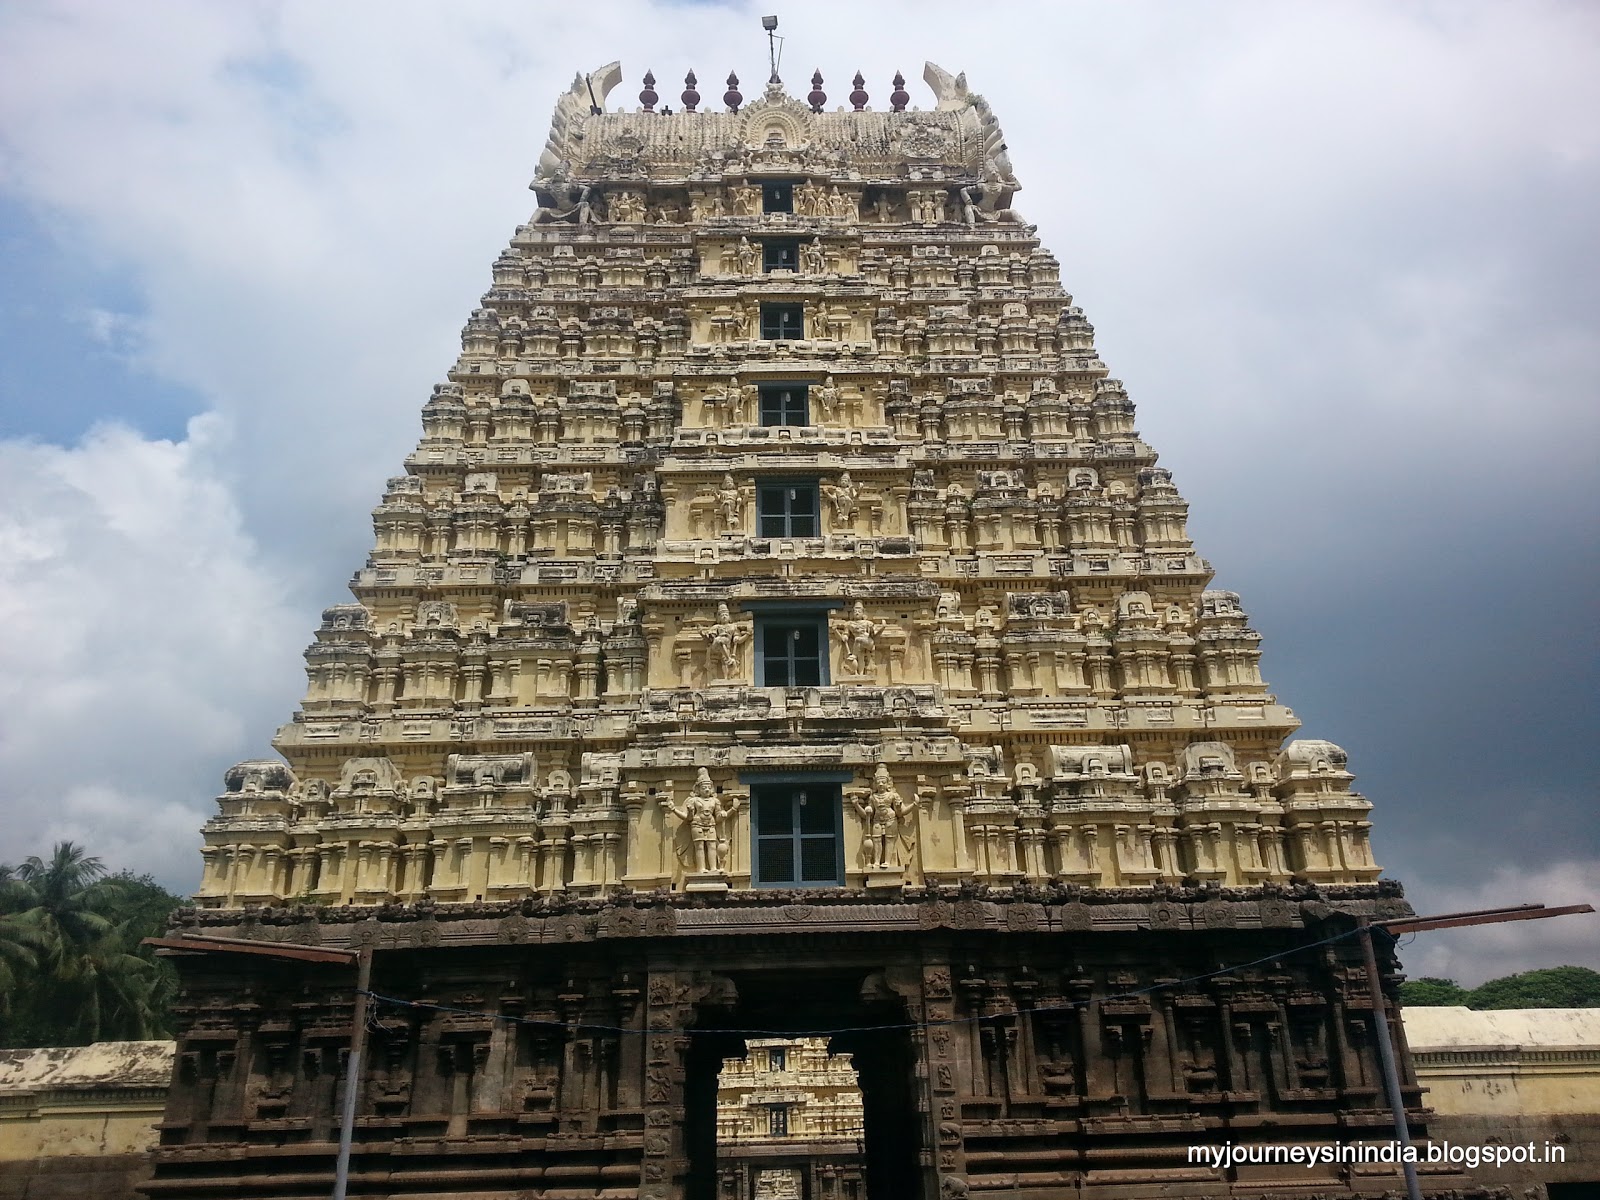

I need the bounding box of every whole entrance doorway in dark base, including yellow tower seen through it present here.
[685,971,925,1200]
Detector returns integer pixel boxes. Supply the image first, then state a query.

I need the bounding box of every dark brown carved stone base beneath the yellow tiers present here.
[144,885,1488,1200]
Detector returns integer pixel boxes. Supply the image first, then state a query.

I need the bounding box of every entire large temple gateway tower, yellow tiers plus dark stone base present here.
[144,64,1469,1200]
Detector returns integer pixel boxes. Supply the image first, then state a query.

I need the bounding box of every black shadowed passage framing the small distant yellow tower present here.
[683,970,926,1200]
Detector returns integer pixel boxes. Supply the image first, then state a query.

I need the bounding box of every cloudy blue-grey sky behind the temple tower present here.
[0,0,1600,982]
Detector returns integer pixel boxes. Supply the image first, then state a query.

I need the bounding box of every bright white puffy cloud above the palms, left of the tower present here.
[0,418,306,886]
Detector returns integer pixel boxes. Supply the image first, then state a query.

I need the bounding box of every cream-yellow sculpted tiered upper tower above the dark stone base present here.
[200,64,1378,907]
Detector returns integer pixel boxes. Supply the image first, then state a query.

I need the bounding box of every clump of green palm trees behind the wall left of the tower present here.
[0,842,179,1046]
